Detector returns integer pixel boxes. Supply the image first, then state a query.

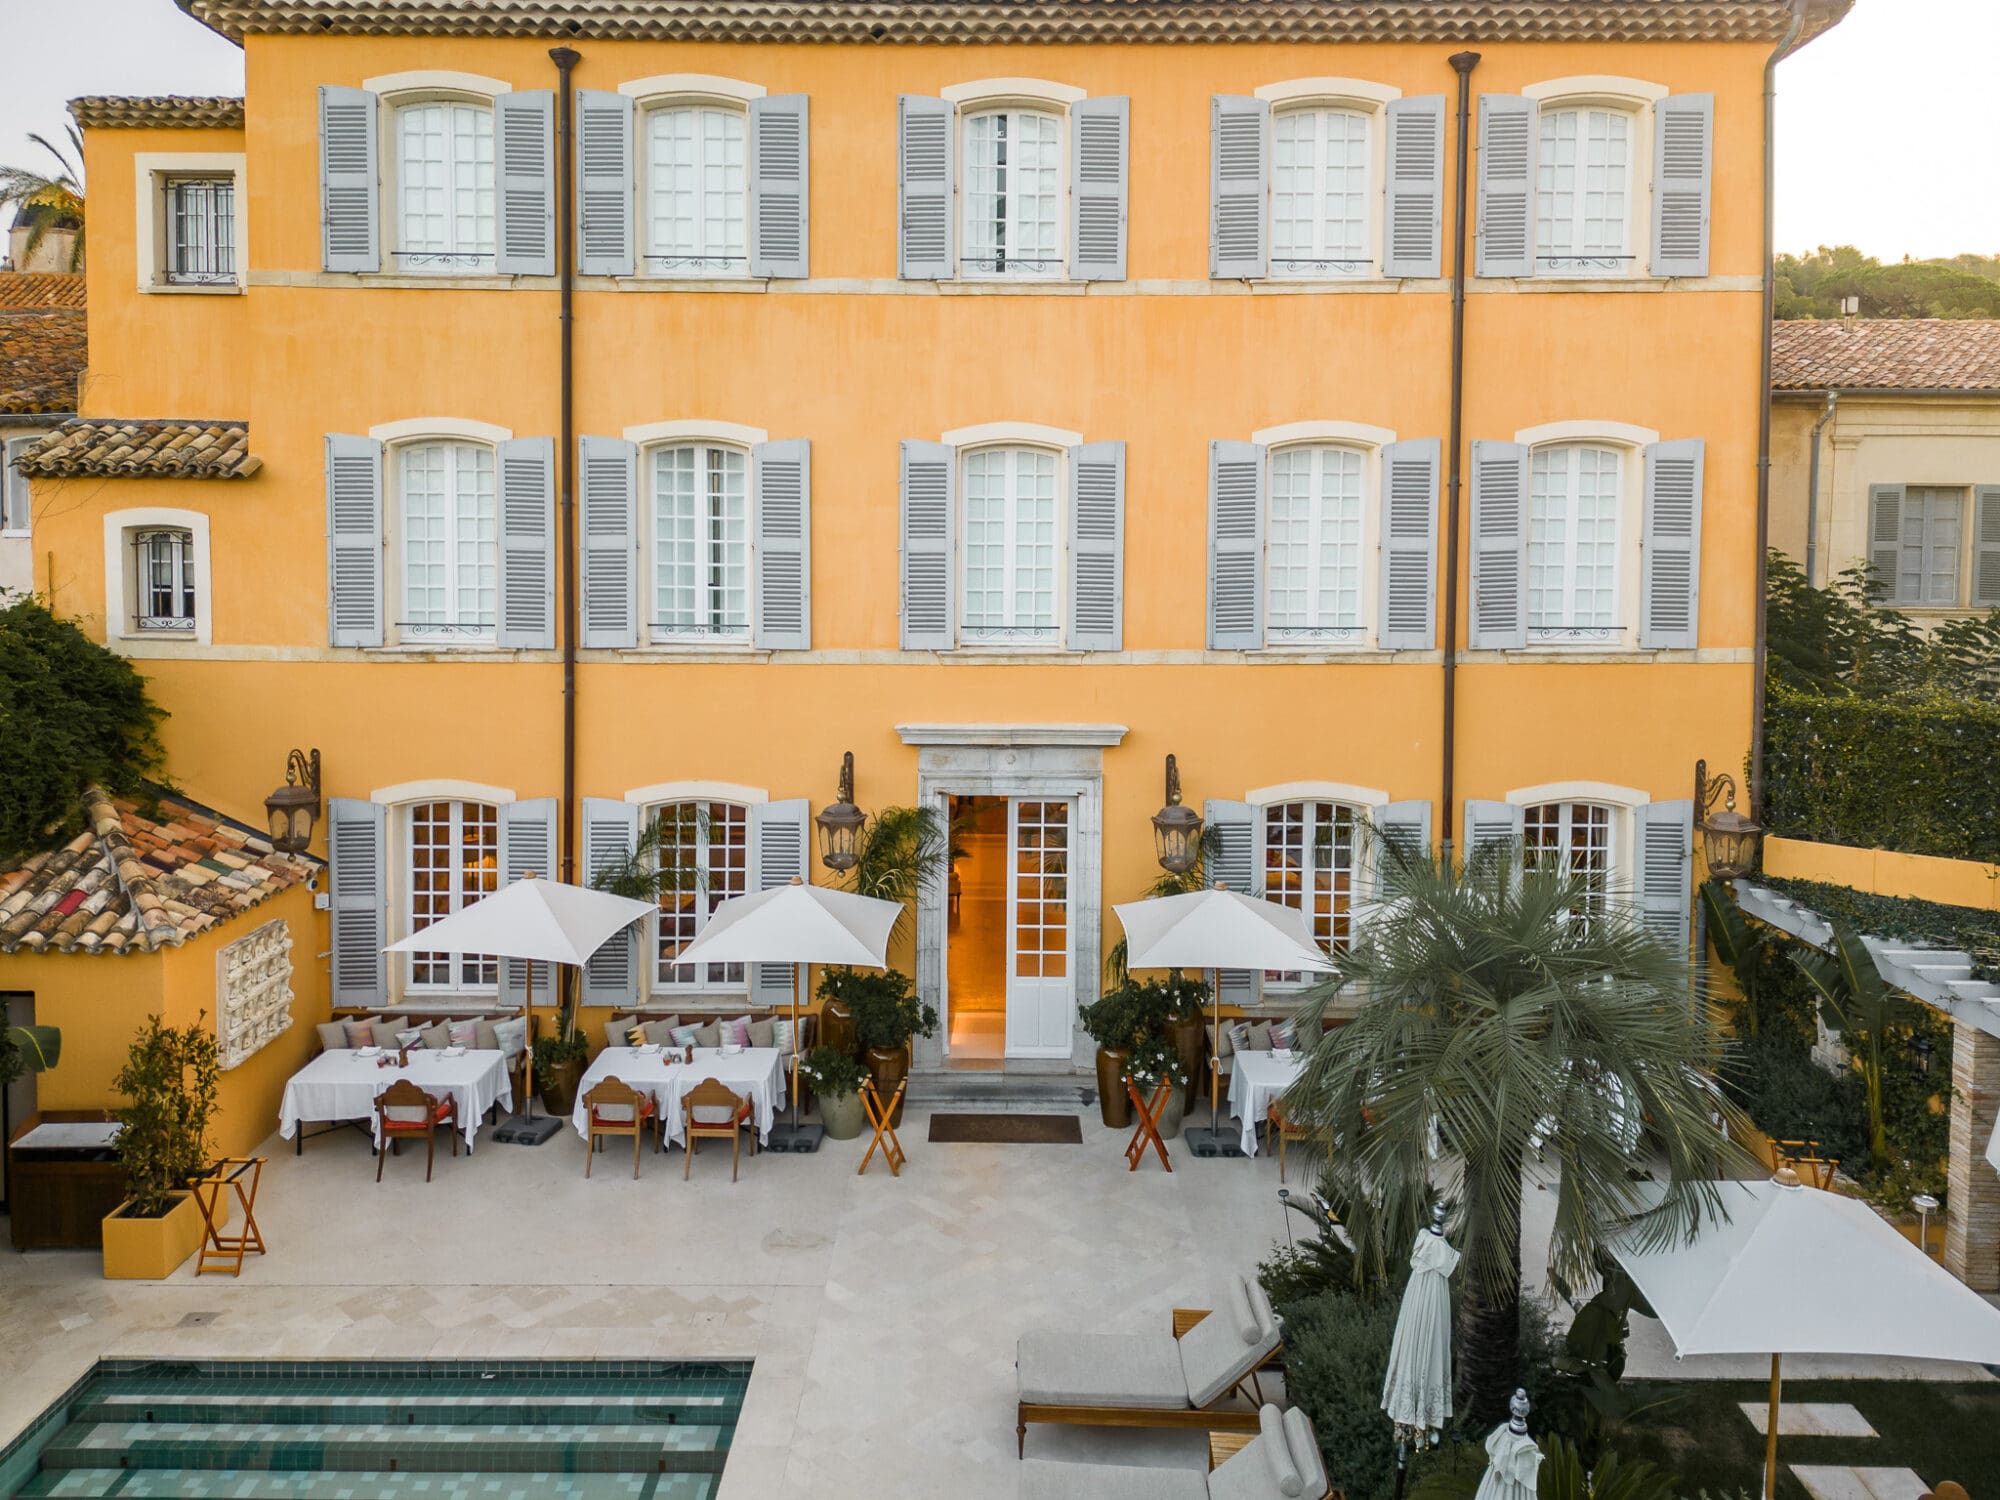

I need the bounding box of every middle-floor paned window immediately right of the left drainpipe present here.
[652,444,750,640]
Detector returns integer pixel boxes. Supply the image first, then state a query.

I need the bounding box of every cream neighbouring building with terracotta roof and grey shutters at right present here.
[1770,318,2000,622]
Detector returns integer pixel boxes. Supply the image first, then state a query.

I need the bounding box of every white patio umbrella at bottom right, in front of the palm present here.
[1610,1168,2000,1496]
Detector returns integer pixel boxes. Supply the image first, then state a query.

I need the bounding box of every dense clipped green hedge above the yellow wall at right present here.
[1764,682,2000,862]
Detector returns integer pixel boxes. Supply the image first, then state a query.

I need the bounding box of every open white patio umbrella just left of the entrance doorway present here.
[674,876,902,1150]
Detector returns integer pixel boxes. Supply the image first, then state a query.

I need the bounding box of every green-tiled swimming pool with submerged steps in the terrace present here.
[0,1360,750,1500]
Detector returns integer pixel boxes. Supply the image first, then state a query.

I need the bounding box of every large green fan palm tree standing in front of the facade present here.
[1286,840,1748,1424]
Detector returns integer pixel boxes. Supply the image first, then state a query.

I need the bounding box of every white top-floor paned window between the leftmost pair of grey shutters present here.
[396,100,494,270]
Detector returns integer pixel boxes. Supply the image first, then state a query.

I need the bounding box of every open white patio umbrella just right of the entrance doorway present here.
[1112,880,1332,1154]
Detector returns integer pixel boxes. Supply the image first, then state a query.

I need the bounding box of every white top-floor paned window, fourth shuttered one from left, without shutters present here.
[1270,110,1374,276]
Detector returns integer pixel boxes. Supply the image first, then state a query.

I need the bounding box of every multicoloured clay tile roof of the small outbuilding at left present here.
[0,786,320,954]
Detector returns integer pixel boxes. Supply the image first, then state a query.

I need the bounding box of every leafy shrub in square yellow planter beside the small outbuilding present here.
[104,1012,222,1280]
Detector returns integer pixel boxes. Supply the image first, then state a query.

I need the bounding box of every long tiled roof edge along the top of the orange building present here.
[188,0,1852,44]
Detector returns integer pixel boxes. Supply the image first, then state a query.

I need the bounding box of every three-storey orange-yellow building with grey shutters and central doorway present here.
[11,0,1840,1072]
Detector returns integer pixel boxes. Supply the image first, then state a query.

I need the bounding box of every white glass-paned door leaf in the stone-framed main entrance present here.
[1006,800,1076,1058]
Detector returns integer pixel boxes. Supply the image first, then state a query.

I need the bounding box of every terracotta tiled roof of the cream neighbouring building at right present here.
[1770,318,2000,392]
